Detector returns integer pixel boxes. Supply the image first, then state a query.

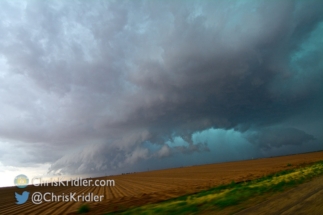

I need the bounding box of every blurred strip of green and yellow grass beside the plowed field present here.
[109,161,323,215]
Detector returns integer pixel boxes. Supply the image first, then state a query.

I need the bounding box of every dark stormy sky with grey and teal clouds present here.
[0,0,323,186]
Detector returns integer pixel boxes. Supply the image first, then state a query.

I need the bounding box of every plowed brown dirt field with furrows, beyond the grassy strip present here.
[0,152,323,215]
